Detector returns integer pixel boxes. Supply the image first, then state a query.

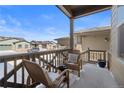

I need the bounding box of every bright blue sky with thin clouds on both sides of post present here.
[0,5,111,41]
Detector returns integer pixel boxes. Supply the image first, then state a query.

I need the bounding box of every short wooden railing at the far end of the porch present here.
[81,50,107,63]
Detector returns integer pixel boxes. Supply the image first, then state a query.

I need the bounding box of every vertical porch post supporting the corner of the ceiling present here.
[70,18,74,49]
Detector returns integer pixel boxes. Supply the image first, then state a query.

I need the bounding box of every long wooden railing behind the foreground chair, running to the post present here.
[0,49,70,87]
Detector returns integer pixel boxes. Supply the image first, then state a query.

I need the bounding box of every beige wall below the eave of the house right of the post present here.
[75,35,110,51]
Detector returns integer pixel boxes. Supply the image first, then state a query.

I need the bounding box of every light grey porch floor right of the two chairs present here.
[70,64,118,88]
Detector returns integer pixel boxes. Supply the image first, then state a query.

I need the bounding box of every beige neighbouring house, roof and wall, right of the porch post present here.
[74,26,111,51]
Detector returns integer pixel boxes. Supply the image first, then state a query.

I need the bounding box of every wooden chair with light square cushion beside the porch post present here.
[64,50,82,77]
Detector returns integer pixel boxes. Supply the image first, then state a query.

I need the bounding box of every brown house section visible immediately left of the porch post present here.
[55,37,70,48]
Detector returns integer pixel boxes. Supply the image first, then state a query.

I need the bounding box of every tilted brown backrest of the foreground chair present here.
[23,60,53,87]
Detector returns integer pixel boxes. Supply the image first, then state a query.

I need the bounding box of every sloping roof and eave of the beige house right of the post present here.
[74,26,111,36]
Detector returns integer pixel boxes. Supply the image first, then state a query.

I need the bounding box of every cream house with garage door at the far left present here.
[0,37,30,52]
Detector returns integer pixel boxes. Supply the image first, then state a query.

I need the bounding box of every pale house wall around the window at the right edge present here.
[110,6,124,87]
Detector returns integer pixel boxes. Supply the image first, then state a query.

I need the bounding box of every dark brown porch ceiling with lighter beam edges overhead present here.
[57,5,112,18]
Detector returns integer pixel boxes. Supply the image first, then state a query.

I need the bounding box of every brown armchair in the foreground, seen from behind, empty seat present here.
[23,59,69,88]
